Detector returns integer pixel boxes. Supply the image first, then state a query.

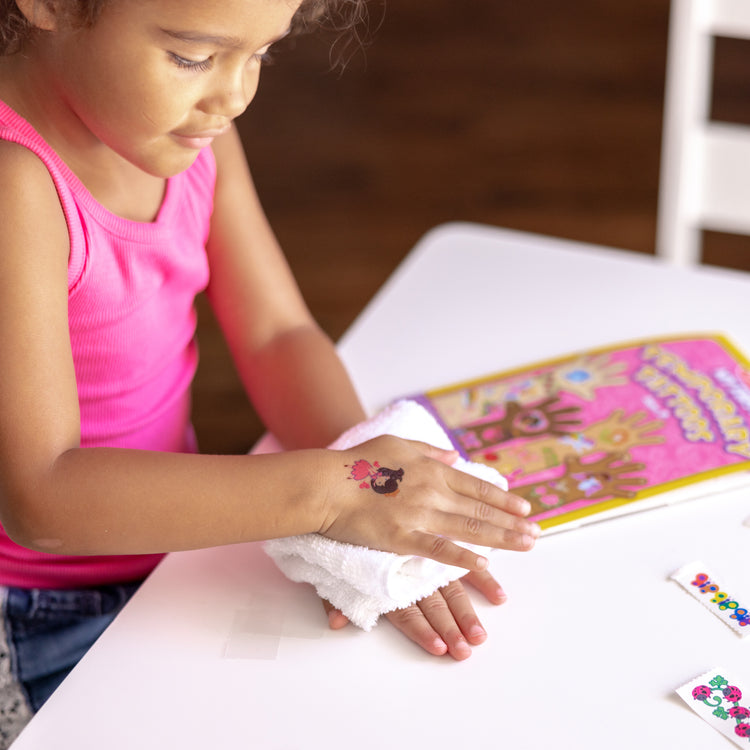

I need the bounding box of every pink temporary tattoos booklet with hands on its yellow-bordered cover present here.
[413,334,750,532]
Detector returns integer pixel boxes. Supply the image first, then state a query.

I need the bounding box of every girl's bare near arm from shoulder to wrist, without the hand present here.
[0,143,325,554]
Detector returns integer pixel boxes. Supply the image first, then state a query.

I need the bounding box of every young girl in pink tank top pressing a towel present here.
[0,0,538,741]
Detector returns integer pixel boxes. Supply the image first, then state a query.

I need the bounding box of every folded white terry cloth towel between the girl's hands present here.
[265,401,508,630]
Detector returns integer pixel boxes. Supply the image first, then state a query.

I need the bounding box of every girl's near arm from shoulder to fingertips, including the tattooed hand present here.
[0,137,533,569]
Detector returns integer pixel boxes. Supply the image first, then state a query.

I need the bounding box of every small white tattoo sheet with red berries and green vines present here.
[676,667,750,748]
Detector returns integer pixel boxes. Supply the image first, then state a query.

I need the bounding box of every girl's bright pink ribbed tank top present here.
[0,102,216,588]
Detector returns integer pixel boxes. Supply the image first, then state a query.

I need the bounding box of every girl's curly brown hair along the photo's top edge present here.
[0,0,367,55]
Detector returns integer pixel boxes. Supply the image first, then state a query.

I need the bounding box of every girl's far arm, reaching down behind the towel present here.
[207,129,365,449]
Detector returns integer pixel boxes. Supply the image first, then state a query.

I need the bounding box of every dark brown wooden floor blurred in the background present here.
[194,0,750,452]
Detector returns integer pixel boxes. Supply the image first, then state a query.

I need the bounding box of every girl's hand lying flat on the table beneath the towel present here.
[323,572,507,661]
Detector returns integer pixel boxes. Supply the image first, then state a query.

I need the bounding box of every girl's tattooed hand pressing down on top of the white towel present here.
[319,435,539,572]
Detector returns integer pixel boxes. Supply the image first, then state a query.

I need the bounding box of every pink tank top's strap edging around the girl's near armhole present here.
[0,108,86,289]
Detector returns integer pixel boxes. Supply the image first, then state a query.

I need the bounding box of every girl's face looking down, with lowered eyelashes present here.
[43,0,301,177]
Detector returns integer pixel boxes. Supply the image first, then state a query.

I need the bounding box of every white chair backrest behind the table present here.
[656,0,750,265]
